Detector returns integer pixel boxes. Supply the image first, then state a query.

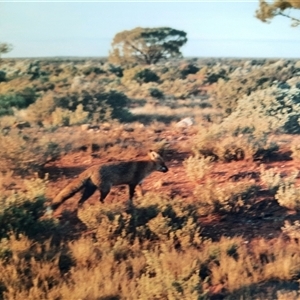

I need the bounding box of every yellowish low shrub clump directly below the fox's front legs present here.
[78,193,201,249]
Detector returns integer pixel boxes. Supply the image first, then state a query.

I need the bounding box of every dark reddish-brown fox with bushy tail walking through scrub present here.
[51,150,168,210]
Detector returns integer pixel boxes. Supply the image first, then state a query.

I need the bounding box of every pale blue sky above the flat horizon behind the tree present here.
[0,0,300,58]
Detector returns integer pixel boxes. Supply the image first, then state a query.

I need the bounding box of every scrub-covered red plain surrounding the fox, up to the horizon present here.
[0,59,300,300]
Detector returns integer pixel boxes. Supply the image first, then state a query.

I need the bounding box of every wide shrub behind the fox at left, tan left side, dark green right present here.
[26,90,131,126]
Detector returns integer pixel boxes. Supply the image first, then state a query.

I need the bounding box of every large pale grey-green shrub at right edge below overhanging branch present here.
[223,84,300,134]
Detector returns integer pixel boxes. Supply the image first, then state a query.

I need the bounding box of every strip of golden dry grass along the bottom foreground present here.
[0,221,300,300]
